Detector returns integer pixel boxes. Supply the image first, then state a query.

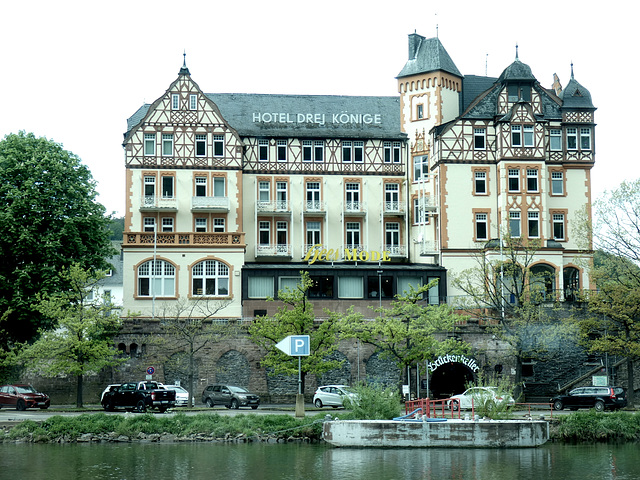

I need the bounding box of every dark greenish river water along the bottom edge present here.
[0,443,640,480]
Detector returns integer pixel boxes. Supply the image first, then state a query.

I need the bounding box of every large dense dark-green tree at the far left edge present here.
[0,132,114,349]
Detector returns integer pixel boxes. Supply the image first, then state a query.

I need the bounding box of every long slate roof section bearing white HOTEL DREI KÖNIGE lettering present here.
[207,93,406,139]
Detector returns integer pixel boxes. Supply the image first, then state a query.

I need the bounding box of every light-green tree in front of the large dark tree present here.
[16,264,122,408]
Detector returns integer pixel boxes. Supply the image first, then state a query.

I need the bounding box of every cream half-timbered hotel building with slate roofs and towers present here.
[123,34,595,318]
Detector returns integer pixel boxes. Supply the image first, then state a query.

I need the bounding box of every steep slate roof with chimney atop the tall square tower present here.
[397,34,462,78]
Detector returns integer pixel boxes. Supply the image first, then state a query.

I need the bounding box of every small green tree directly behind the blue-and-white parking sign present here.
[248,272,341,388]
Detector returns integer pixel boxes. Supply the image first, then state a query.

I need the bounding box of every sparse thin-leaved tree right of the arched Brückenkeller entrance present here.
[452,234,575,392]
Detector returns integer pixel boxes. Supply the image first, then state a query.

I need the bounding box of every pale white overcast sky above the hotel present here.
[0,0,640,216]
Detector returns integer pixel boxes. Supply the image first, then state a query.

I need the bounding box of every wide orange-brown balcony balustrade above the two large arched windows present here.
[122,232,246,248]
